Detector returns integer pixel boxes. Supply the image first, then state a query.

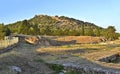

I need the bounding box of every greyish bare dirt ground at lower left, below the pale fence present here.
[0,43,53,74]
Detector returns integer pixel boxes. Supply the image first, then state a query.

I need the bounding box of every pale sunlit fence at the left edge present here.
[0,37,18,49]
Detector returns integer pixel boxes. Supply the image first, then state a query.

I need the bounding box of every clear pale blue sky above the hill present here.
[0,0,120,32]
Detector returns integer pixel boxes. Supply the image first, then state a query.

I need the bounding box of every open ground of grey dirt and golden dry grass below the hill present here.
[0,35,120,74]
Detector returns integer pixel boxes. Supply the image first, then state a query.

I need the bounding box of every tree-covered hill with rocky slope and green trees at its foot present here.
[0,15,119,40]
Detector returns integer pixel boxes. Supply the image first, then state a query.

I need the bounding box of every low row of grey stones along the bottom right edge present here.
[58,63,120,74]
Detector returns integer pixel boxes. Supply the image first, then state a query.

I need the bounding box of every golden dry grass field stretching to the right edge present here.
[36,41,120,68]
